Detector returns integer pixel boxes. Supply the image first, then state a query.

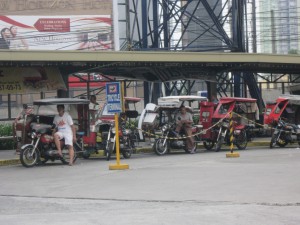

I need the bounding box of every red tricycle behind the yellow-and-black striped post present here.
[199,97,259,151]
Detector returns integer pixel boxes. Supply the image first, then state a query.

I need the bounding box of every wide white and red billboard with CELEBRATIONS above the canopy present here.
[0,15,113,51]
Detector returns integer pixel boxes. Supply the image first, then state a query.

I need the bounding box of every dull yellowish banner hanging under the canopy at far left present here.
[0,67,66,94]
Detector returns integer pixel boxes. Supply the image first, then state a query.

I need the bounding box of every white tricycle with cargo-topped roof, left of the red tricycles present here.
[139,95,207,156]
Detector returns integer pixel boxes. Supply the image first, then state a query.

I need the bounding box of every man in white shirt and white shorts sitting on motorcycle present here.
[53,105,76,166]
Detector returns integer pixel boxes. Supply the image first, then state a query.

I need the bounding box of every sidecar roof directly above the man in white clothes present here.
[33,98,90,105]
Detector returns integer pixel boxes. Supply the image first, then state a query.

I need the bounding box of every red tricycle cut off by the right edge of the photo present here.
[264,95,300,148]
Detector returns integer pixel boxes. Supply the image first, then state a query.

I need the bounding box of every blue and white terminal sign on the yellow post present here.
[106,82,122,113]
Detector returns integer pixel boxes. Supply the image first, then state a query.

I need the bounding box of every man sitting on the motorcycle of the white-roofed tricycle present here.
[175,105,196,153]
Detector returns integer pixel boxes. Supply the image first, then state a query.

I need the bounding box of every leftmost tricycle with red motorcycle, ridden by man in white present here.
[16,98,89,167]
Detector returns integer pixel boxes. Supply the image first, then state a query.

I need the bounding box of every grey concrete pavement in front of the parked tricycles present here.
[0,147,300,225]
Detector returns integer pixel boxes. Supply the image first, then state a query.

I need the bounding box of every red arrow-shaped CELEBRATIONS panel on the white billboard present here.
[34,18,70,32]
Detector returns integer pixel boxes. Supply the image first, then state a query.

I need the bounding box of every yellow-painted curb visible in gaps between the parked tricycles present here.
[0,142,270,166]
